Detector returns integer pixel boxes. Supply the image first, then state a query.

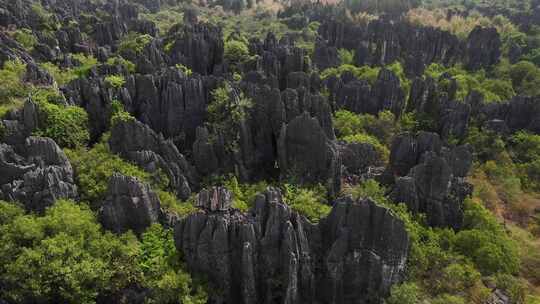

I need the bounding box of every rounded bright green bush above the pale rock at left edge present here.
[32,90,90,148]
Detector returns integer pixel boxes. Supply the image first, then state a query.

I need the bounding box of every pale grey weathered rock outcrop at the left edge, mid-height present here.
[0,137,78,212]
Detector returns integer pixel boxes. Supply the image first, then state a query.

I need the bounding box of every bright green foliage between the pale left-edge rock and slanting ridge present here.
[65,137,152,204]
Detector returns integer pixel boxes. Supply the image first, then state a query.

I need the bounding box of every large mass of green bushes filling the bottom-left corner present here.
[0,201,206,304]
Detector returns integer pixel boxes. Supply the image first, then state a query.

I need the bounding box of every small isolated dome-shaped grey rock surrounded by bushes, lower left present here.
[98,174,162,234]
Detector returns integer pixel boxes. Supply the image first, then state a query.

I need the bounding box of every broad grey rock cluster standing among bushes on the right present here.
[388,132,472,229]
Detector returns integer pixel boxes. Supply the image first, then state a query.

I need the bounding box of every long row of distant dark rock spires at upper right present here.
[319,18,502,76]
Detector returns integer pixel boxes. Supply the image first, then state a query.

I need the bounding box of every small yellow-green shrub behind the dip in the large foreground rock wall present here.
[281,184,332,223]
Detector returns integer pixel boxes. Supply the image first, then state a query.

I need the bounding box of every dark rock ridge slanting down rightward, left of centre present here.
[109,119,198,200]
